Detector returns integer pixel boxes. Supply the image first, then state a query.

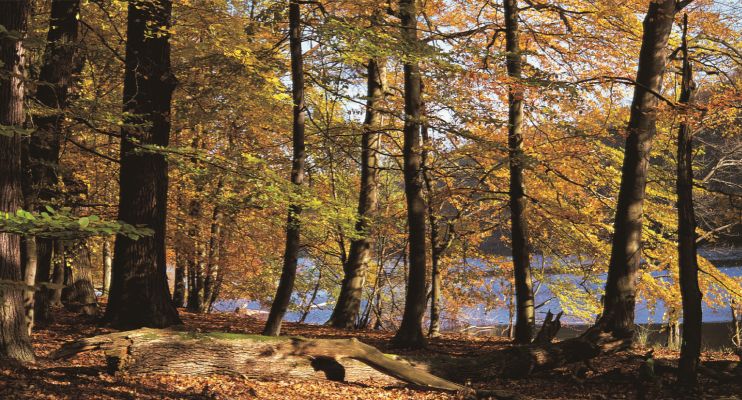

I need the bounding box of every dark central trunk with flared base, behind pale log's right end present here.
[392,0,427,348]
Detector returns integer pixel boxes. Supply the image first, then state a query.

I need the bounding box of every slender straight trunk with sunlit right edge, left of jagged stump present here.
[504,0,536,344]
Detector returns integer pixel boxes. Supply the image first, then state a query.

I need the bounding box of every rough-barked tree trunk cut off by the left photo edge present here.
[0,0,34,362]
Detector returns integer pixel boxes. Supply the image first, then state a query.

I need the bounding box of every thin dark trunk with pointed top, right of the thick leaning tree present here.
[677,14,702,385]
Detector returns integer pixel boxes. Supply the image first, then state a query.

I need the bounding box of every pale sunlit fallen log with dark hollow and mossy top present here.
[50,328,523,399]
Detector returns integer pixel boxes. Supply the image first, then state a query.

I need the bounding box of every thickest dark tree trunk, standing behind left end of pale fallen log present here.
[105,0,180,328]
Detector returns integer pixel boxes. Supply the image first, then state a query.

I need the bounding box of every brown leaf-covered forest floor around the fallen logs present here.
[0,310,742,400]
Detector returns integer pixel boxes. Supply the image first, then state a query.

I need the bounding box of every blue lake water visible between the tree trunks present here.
[214,252,742,326]
